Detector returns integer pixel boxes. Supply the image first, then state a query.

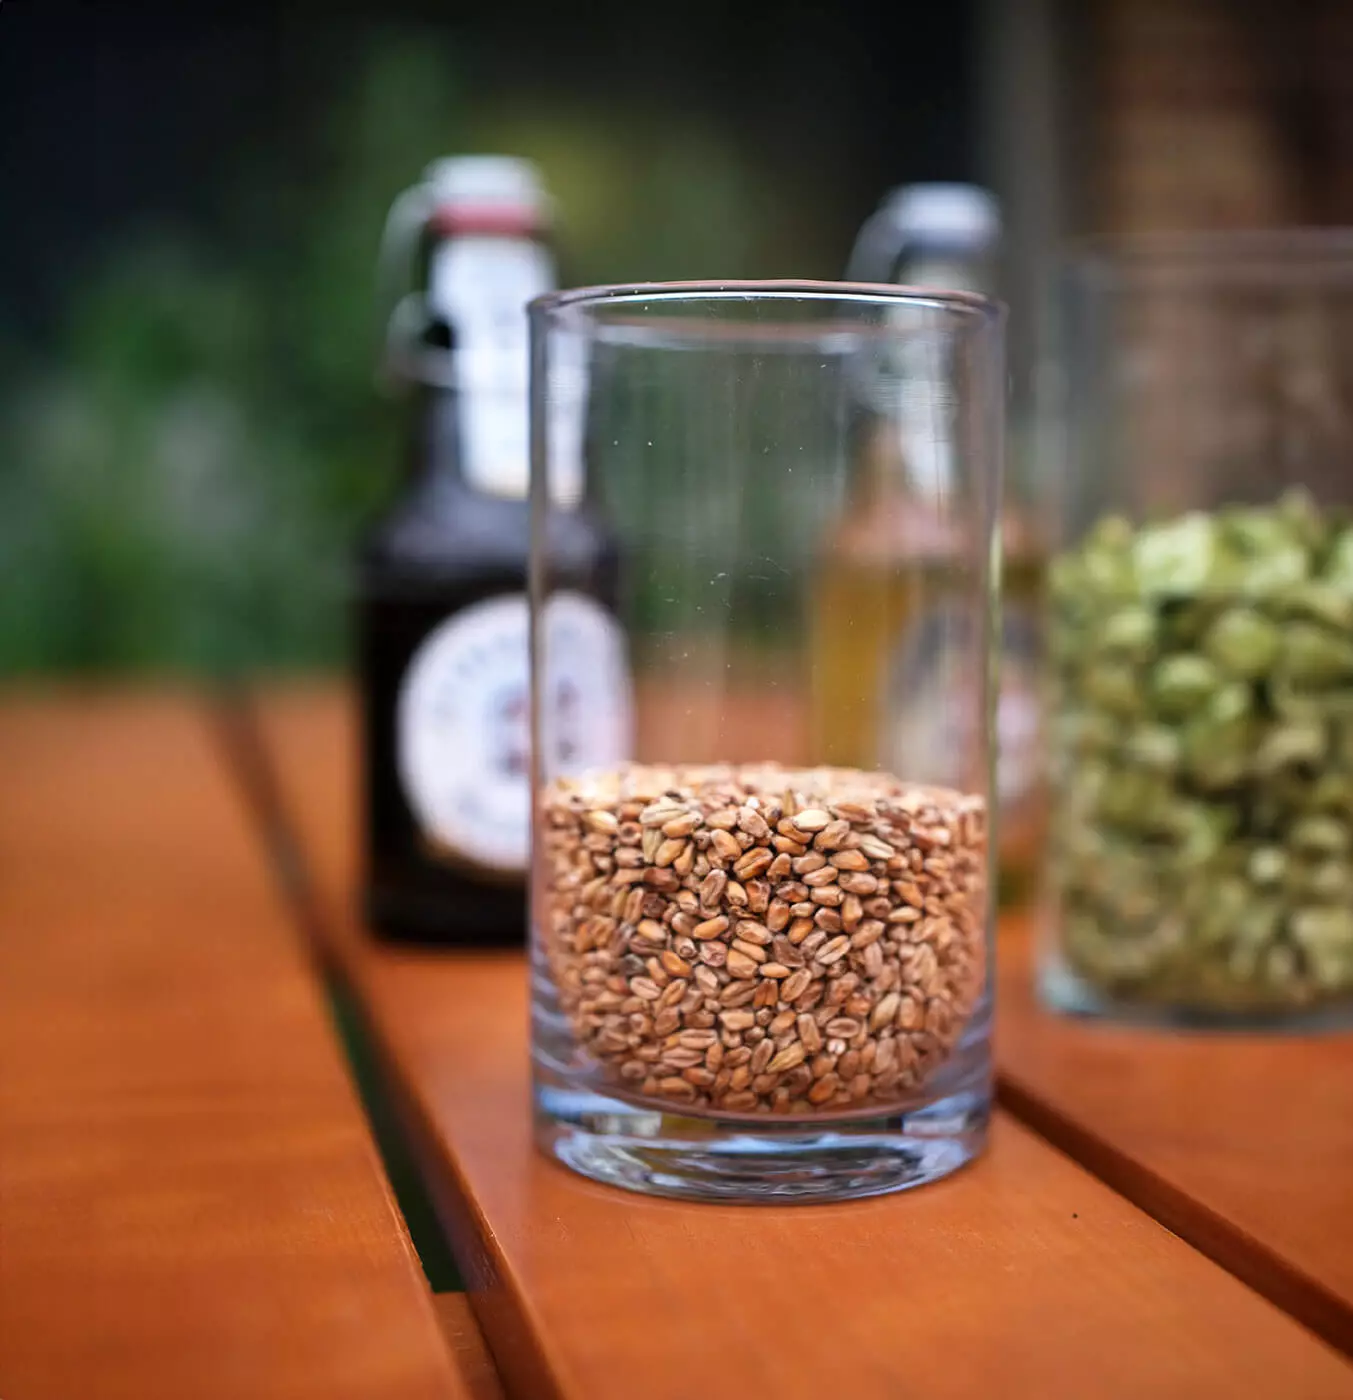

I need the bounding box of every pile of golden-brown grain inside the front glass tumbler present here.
[541,764,986,1114]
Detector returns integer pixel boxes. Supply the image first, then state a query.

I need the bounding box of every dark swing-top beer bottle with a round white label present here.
[357,155,629,945]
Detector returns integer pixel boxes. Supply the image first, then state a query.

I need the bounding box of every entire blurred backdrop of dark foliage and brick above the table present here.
[0,0,1353,675]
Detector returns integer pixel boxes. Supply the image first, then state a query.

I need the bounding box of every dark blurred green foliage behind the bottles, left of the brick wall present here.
[0,0,979,672]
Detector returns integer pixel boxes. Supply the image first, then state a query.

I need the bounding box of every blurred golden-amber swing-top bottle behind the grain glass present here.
[812,183,1043,900]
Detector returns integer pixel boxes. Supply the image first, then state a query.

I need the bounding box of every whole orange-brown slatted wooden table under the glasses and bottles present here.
[0,687,1353,1400]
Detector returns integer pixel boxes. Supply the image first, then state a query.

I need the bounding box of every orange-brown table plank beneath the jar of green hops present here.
[997,921,1353,1352]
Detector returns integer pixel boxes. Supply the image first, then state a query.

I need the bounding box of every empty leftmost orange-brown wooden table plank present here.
[0,696,471,1400]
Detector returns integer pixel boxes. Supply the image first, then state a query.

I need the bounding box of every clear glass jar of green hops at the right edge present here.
[1041,232,1353,1025]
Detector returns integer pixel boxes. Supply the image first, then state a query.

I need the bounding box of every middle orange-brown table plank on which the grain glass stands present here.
[243,690,1353,1400]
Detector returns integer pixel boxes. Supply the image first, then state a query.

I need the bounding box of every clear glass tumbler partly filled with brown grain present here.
[531,283,1003,1200]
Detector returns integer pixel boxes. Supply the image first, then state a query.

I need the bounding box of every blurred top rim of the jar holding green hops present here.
[1062,225,1353,283]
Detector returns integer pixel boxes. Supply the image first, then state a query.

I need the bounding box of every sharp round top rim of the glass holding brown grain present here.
[527,277,1006,325]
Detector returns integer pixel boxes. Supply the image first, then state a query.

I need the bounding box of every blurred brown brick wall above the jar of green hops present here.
[1088,0,1353,232]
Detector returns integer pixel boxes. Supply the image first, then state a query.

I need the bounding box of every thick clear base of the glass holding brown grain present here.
[534,1070,990,1203]
